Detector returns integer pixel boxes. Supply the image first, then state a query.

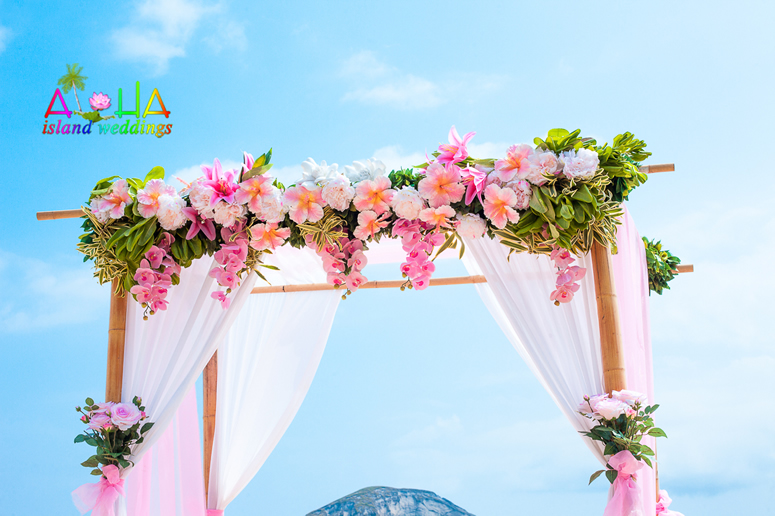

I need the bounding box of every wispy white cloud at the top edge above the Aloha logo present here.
[112,0,247,75]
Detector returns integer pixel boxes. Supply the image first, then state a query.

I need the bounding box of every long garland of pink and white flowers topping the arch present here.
[78,126,650,317]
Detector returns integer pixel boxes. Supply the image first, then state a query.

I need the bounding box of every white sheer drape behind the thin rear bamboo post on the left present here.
[208,246,342,510]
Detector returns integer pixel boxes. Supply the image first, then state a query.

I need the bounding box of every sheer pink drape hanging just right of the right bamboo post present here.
[613,206,659,515]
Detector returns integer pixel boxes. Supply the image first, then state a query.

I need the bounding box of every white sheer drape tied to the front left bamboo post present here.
[118,257,256,516]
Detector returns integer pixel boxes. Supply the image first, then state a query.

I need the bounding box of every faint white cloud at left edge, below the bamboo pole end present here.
[0,250,110,333]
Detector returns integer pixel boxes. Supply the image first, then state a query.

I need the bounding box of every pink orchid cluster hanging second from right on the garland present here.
[393,219,444,290]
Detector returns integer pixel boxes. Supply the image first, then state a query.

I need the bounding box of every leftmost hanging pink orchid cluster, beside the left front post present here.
[129,237,180,319]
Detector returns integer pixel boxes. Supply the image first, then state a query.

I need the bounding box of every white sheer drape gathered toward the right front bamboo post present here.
[463,237,605,463]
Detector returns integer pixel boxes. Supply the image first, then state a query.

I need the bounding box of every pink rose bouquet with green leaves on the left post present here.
[75,396,153,475]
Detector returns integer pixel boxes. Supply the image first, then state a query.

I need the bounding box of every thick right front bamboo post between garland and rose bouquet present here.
[592,241,627,394]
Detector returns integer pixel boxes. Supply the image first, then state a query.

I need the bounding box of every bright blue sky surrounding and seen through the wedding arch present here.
[0,0,775,516]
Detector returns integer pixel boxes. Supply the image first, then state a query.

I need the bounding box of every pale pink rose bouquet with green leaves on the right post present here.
[579,390,667,484]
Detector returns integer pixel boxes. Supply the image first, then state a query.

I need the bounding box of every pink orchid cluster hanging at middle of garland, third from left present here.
[305,233,369,299]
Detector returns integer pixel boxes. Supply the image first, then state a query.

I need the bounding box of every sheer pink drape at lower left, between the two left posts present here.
[126,388,205,516]
